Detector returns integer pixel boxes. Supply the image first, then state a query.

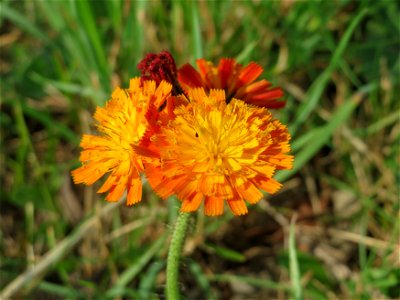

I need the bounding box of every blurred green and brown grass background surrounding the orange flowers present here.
[0,0,400,299]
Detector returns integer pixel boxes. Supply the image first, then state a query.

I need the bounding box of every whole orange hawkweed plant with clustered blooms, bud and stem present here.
[72,51,293,300]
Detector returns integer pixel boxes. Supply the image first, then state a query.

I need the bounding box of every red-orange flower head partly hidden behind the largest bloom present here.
[178,58,286,108]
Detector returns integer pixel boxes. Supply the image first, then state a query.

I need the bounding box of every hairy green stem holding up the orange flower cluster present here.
[165,212,190,300]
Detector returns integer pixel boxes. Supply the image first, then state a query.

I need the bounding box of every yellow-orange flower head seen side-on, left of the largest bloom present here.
[72,78,172,205]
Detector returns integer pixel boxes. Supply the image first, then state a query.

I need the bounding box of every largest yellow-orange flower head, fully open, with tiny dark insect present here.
[145,88,293,216]
